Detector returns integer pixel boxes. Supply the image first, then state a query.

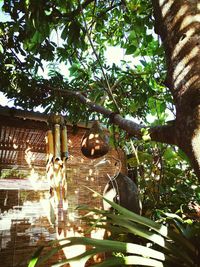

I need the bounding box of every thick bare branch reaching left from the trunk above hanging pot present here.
[52,87,176,145]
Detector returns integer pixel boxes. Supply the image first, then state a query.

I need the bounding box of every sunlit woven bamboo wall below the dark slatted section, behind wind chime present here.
[0,128,126,267]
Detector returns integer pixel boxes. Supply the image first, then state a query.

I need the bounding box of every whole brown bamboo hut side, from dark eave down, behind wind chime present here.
[0,107,126,267]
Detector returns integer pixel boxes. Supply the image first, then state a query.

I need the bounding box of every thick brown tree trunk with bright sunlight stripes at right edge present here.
[152,0,200,178]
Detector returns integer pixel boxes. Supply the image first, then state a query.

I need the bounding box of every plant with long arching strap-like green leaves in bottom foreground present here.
[28,195,200,267]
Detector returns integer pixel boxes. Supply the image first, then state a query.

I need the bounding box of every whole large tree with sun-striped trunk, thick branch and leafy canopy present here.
[0,0,200,180]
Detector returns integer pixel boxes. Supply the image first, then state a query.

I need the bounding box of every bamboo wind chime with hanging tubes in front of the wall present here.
[47,116,68,236]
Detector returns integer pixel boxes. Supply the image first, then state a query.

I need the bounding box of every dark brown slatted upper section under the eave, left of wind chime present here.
[0,106,87,169]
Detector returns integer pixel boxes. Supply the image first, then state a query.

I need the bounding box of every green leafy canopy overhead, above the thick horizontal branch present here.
[0,0,173,123]
